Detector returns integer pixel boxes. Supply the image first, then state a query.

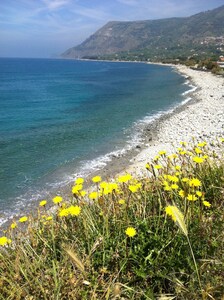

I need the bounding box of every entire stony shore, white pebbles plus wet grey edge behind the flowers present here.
[1,63,224,227]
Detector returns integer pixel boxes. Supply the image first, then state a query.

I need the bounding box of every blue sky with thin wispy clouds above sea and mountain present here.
[0,0,224,57]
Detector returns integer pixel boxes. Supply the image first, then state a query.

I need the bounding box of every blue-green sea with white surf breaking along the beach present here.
[0,58,193,224]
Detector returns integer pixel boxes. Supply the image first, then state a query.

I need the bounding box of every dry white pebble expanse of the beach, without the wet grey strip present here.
[125,65,224,175]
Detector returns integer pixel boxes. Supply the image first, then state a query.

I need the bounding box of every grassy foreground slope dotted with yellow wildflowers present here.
[0,139,224,300]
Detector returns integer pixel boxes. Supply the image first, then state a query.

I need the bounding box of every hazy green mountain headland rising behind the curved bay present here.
[62,5,224,59]
